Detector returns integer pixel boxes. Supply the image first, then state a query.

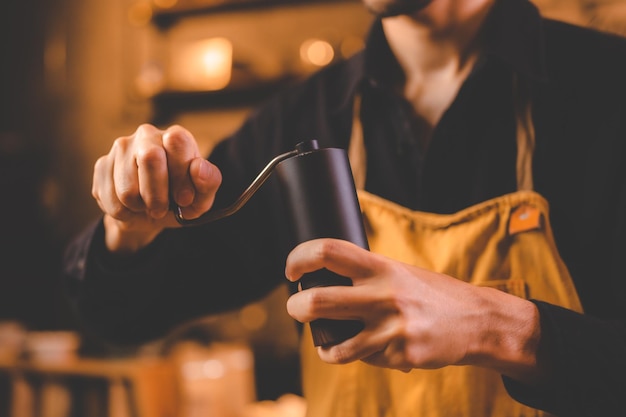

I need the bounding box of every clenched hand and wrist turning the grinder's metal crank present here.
[92,124,222,254]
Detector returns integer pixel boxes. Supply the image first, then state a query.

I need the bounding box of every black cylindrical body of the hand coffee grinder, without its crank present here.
[274,141,369,346]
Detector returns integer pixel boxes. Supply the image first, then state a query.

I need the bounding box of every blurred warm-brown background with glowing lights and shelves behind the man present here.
[0,0,626,417]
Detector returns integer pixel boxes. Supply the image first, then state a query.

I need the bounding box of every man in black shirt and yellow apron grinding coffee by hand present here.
[67,0,626,416]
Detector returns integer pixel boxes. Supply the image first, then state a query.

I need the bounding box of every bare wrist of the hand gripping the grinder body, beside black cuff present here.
[466,288,547,384]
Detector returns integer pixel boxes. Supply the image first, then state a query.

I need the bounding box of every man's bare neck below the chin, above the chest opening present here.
[382,0,492,79]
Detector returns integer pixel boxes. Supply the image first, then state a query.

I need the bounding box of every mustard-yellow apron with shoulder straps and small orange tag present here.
[301,83,582,417]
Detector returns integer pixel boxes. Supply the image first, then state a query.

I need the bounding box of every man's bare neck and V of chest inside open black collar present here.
[382,0,494,143]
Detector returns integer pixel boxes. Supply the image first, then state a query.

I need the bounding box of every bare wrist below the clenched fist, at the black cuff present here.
[104,215,161,255]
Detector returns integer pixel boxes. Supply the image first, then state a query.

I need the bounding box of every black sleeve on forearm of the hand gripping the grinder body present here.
[503,301,626,417]
